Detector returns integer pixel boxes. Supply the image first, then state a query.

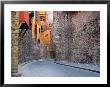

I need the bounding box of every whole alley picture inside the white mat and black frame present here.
[11,11,100,77]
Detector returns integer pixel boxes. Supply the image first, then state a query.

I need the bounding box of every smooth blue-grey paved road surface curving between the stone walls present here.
[19,61,100,77]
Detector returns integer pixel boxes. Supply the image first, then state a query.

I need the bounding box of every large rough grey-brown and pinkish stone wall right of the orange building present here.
[53,11,100,65]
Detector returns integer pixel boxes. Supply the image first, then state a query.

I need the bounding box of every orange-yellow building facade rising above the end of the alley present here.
[32,11,52,44]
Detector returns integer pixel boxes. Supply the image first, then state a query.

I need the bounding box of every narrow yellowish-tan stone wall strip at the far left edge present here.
[11,11,19,76]
